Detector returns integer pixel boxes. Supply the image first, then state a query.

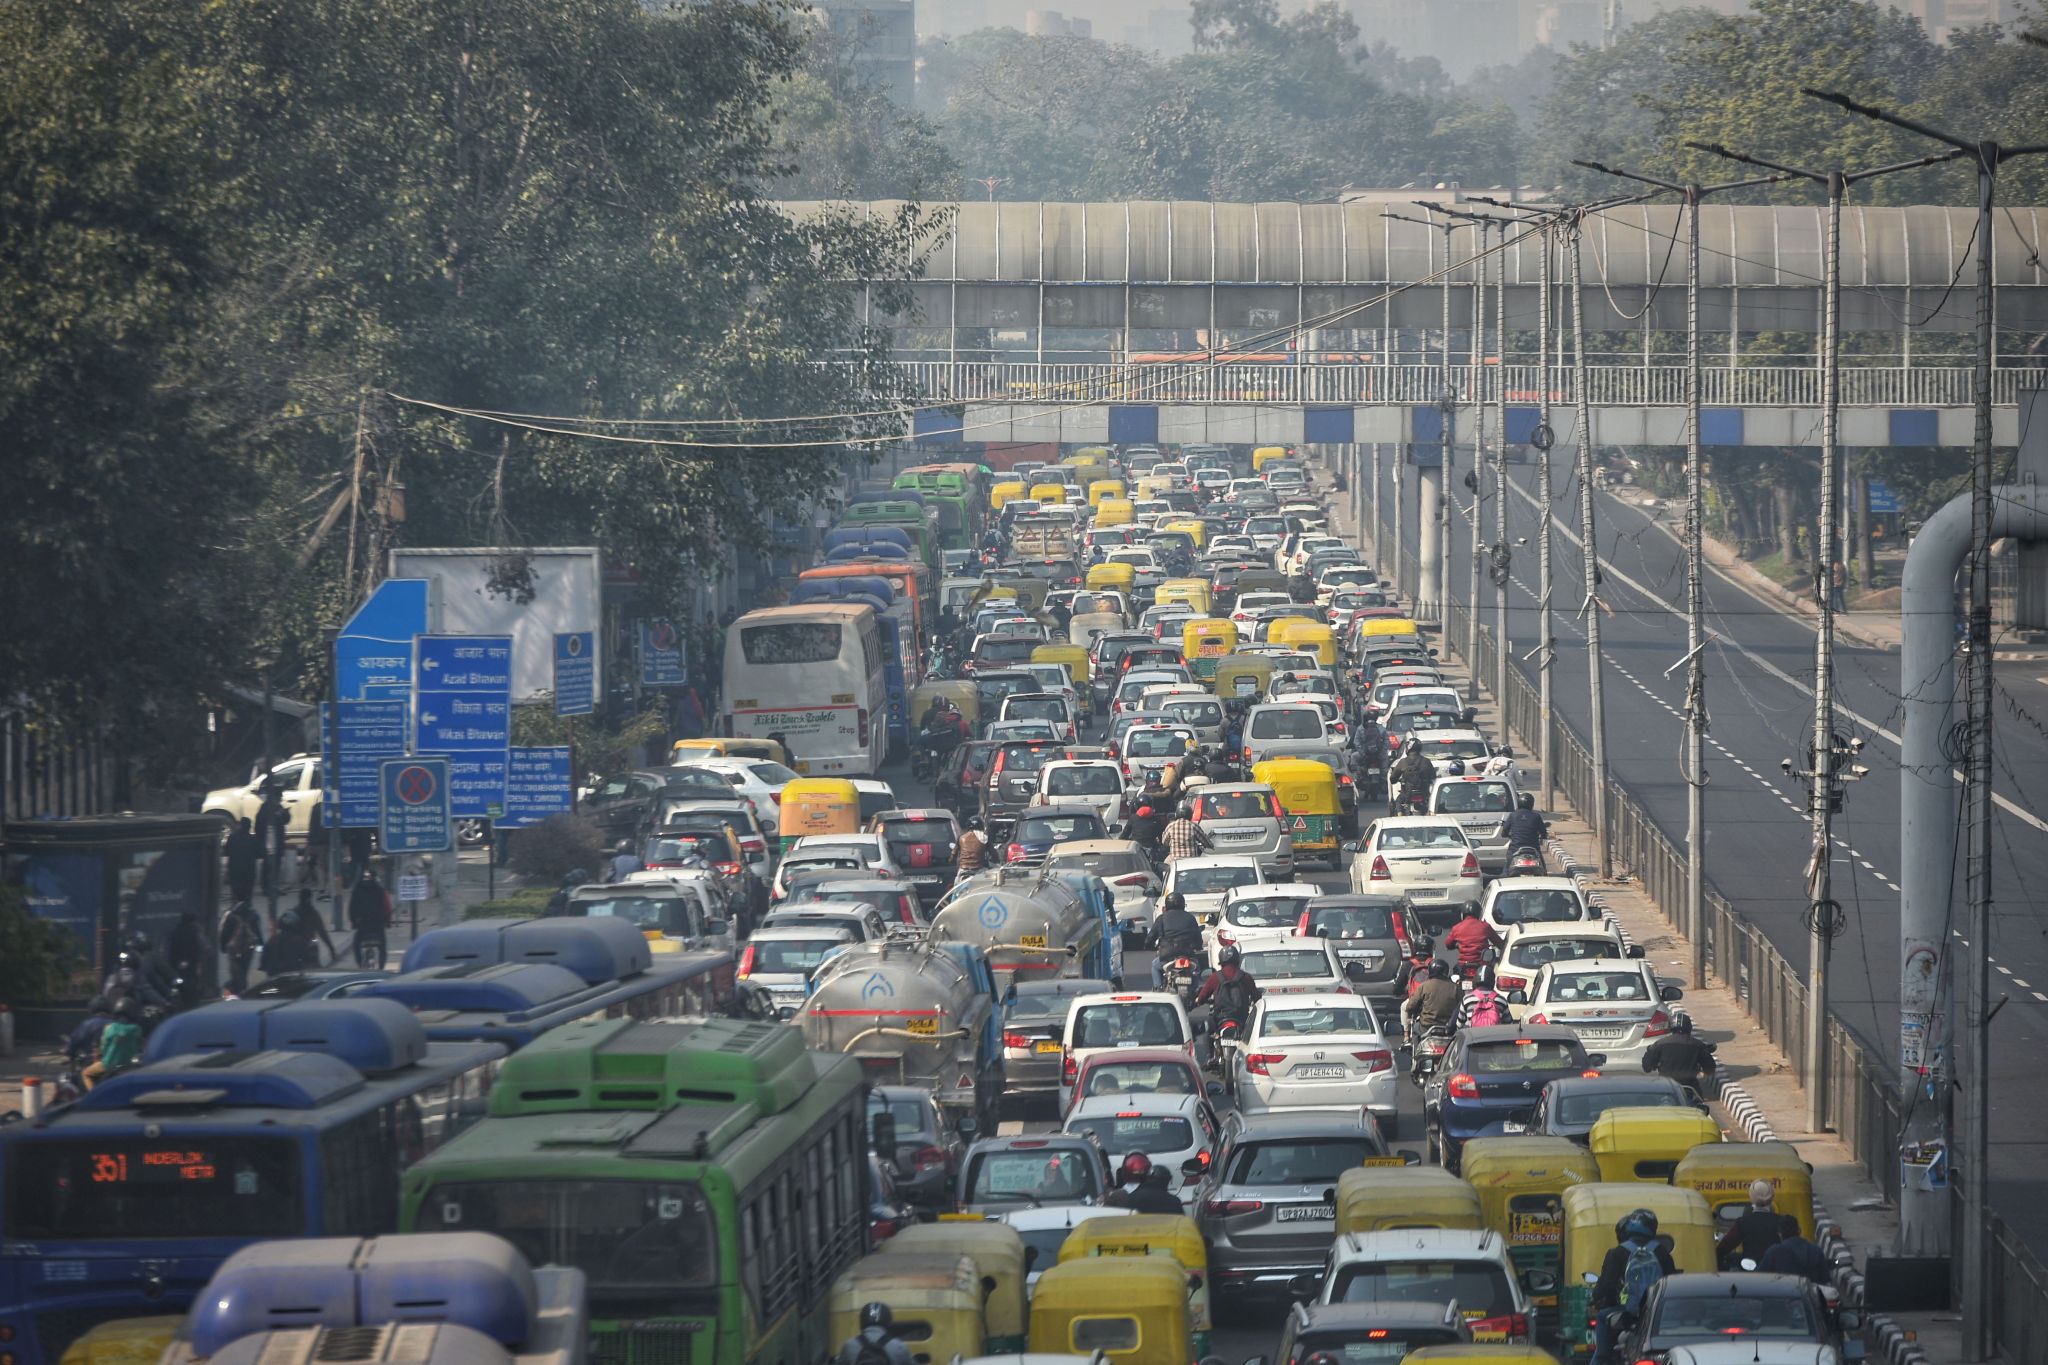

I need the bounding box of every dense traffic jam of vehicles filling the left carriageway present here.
[16,444,1855,1365]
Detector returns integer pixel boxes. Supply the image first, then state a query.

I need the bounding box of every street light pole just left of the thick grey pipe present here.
[1686,141,1958,1132]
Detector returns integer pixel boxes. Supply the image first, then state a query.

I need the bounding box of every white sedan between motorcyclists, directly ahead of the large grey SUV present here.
[1237,993,1399,1134]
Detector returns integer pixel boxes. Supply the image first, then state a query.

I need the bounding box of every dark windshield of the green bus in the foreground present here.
[420,1179,719,1312]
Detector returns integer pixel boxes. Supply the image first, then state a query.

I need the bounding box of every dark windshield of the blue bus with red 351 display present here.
[6,1138,305,1242]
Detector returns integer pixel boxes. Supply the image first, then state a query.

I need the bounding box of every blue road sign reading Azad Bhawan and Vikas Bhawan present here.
[412,634,512,819]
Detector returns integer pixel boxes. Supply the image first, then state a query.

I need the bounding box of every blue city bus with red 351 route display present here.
[0,999,506,1365]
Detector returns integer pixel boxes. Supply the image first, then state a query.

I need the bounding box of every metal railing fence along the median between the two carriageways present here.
[1442,604,2048,1361]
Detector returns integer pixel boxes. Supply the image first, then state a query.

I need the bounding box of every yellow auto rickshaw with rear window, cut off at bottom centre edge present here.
[1030,1252,1196,1365]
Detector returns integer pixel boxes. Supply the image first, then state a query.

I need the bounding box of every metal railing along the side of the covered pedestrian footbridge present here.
[899,358,2042,407]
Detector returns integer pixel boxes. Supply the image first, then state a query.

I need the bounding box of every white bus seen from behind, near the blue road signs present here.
[723,602,889,778]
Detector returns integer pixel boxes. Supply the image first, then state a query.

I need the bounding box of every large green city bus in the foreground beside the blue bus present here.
[399,1019,868,1365]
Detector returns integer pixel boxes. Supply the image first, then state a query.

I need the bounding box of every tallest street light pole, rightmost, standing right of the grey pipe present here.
[1802,88,2048,1361]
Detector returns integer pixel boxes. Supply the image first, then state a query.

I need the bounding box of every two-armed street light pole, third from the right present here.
[1573,162,1786,990]
